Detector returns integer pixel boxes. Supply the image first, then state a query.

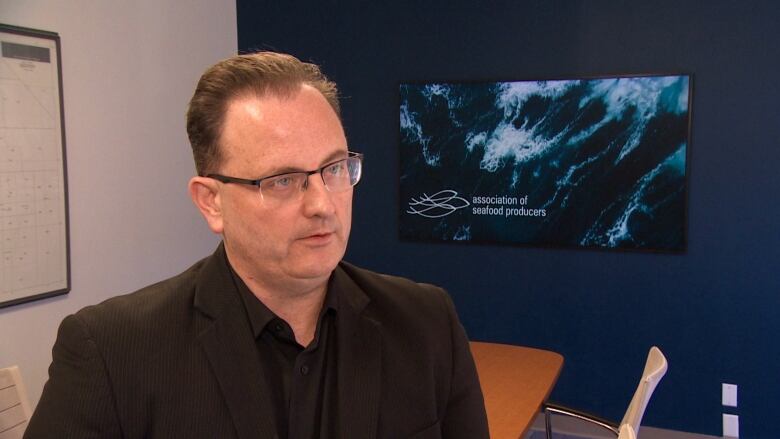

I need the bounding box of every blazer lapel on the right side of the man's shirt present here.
[332,267,382,439]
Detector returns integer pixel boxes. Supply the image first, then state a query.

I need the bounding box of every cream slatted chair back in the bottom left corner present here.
[0,366,32,439]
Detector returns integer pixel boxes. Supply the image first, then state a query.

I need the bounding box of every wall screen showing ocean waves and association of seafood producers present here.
[400,76,690,252]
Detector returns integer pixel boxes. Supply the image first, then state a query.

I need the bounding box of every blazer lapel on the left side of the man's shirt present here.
[195,245,278,439]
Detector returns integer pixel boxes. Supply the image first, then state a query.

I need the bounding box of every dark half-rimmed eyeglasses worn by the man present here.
[206,152,363,205]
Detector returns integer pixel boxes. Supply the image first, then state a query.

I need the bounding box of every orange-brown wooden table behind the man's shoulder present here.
[471,341,563,439]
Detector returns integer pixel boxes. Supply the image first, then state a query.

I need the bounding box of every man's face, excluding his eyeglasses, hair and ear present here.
[212,85,352,287]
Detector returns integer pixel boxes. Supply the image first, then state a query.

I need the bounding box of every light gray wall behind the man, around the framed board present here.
[0,0,237,410]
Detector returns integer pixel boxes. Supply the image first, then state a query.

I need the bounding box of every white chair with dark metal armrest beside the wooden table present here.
[544,346,669,439]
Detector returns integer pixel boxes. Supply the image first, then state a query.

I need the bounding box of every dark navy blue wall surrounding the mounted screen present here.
[238,0,780,439]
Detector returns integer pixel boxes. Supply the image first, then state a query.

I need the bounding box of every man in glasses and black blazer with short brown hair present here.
[25,52,488,439]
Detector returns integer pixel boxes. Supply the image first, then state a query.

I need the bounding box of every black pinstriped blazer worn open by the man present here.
[25,246,488,439]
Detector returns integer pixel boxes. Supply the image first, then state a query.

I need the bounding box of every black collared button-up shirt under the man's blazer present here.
[228,263,338,439]
